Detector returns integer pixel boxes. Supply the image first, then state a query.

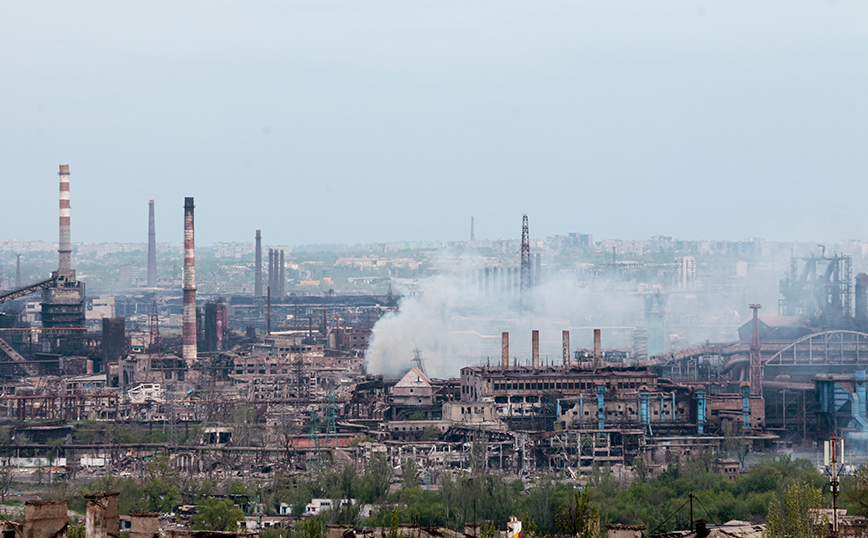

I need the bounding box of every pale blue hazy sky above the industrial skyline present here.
[0,0,868,244]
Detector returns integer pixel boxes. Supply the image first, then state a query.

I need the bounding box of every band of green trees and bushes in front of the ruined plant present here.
[42,448,868,538]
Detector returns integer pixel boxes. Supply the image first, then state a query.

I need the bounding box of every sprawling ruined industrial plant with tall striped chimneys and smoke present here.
[0,165,868,532]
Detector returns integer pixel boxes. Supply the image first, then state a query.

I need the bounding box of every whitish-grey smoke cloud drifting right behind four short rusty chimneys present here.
[366,250,776,378]
